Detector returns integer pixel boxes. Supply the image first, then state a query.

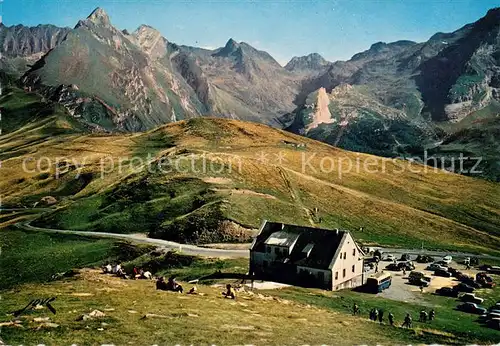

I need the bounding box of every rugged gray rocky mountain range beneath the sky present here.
[0,8,500,181]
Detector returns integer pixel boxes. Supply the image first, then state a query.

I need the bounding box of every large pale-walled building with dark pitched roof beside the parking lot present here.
[250,221,364,290]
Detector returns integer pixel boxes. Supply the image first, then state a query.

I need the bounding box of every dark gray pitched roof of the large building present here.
[251,221,349,269]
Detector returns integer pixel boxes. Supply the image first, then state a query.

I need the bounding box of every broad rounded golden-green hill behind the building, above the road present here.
[0,104,500,252]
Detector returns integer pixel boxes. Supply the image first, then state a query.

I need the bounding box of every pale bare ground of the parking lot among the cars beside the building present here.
[368,261,478,304]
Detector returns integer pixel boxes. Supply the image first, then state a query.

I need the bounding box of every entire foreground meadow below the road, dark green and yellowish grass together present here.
[0,229,500,345]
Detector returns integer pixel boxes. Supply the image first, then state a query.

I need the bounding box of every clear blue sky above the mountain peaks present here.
[0,0,500,64]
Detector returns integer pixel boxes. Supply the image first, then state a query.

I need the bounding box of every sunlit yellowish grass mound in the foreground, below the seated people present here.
[0,271,420,345]
